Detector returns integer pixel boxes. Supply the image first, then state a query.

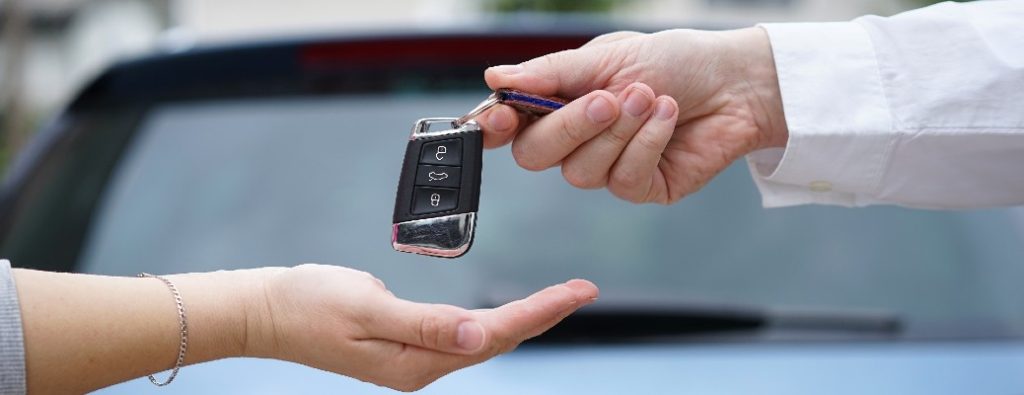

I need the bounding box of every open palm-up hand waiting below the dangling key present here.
[247,264,597,391]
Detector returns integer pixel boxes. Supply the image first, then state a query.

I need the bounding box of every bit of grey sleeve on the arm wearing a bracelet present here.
[0,259,26,395]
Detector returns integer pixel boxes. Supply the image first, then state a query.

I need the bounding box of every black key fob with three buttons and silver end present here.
[391,118,483,258]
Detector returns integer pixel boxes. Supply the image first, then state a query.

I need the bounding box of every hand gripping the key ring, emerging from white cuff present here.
[476,28,787,204]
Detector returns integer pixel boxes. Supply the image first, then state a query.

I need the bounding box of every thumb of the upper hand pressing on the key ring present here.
[483,46,617,99]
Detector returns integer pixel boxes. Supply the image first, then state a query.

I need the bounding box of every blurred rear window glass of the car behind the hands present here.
[36,92,1024,336]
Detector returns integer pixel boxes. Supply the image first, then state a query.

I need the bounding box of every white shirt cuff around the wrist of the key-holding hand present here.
[746,23,895,207]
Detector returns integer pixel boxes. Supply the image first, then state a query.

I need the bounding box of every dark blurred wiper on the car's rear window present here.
[499,300,903,343]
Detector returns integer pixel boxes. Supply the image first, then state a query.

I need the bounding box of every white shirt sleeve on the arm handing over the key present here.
[748,0,1024,208]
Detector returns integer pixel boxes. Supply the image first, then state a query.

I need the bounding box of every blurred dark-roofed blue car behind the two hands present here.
[0,27,1024,394]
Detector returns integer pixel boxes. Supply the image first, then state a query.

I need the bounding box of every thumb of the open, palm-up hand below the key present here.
[367,297,487,354]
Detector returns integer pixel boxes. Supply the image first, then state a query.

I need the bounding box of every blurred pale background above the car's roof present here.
[0,0,934,164]
